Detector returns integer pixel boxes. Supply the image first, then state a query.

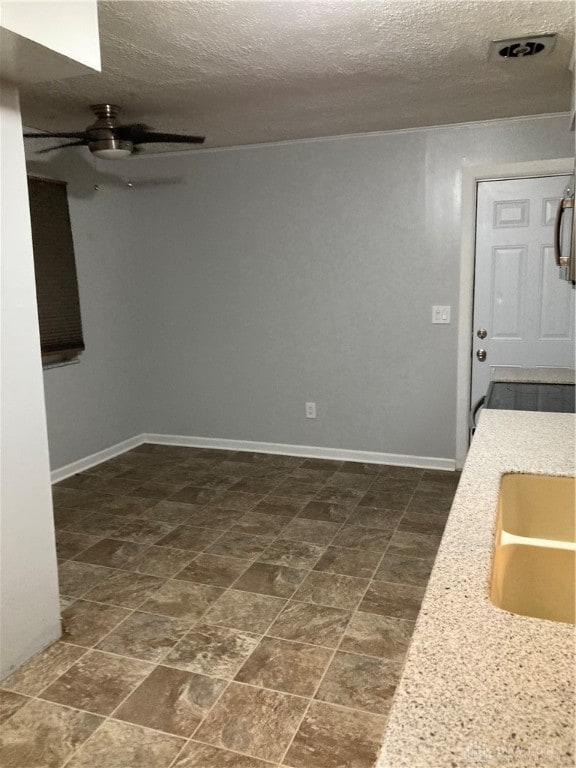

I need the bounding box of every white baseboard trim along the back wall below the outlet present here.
[140,433,456,472]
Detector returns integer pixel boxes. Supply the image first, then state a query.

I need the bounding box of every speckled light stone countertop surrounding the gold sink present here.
[377,410,575,768]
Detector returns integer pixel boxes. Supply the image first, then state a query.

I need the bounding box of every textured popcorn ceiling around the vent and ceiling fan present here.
[21,0,574,147]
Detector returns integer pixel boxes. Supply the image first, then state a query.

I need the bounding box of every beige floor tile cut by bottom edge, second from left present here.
[66,720,186,768]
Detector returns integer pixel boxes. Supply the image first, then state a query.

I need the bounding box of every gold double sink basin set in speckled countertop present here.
[490,474,576,624]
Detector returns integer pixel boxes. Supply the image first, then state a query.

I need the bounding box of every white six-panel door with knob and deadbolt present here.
[471,176,575,404]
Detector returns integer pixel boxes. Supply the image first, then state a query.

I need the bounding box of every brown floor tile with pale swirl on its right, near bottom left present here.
[114,666,228,738]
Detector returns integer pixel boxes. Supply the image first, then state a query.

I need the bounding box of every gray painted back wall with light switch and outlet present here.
[137,115,573,458]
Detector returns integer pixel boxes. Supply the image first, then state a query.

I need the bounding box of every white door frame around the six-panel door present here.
[456,157,574,469]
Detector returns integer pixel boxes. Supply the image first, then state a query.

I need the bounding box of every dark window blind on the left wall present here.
[28,176,84,359]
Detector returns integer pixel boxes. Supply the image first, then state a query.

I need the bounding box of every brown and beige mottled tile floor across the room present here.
[0,445,458,768]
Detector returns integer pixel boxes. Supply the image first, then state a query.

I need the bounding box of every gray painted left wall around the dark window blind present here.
[27,152,145,469]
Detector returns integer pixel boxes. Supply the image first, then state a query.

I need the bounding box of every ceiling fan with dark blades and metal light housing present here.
[24,104,204,160]
